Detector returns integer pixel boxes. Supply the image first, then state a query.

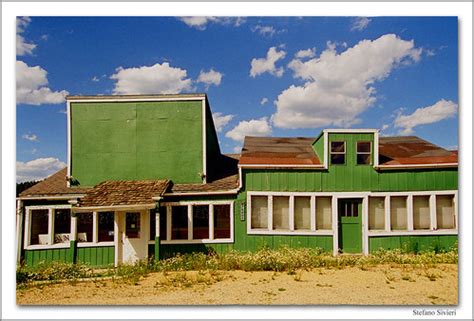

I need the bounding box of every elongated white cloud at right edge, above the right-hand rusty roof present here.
[394,99,458,135]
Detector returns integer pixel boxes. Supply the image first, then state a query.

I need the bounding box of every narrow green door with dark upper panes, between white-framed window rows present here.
[338,198,362,253]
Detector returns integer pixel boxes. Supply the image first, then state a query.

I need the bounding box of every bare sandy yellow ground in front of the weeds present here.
[16,264,458,305]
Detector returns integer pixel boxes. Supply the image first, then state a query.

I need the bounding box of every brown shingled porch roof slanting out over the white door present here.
[78,180,170,207]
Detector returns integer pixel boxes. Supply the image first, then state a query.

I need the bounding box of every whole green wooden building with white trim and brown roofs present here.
[17,94,458,266]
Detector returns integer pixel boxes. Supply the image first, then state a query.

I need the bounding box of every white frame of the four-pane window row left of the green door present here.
[247,192,335,236]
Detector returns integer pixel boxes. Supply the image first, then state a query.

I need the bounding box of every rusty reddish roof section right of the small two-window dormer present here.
[379,136,458,165]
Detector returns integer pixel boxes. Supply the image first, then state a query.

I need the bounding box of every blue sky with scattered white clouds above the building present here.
[16,17,458,181]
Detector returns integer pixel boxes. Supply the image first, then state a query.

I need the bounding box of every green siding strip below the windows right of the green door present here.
[369,235,458,253]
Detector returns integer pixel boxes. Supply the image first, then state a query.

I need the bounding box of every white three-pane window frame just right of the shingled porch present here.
[148,201,234,245]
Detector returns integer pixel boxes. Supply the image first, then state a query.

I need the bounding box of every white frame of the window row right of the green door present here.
[368,190,458,236]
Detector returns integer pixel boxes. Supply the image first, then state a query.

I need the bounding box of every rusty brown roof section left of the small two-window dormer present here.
[239,136,321,165]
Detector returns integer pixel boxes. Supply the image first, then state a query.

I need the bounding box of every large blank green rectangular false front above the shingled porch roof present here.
[71,101,203,186]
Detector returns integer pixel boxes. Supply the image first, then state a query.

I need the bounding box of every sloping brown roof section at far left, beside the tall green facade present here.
[20,168,90,198]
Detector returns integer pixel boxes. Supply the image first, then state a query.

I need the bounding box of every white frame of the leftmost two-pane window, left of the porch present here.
[23,205,73,250]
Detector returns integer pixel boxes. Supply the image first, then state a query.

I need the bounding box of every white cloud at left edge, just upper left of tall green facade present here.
[16,61,69,105]
